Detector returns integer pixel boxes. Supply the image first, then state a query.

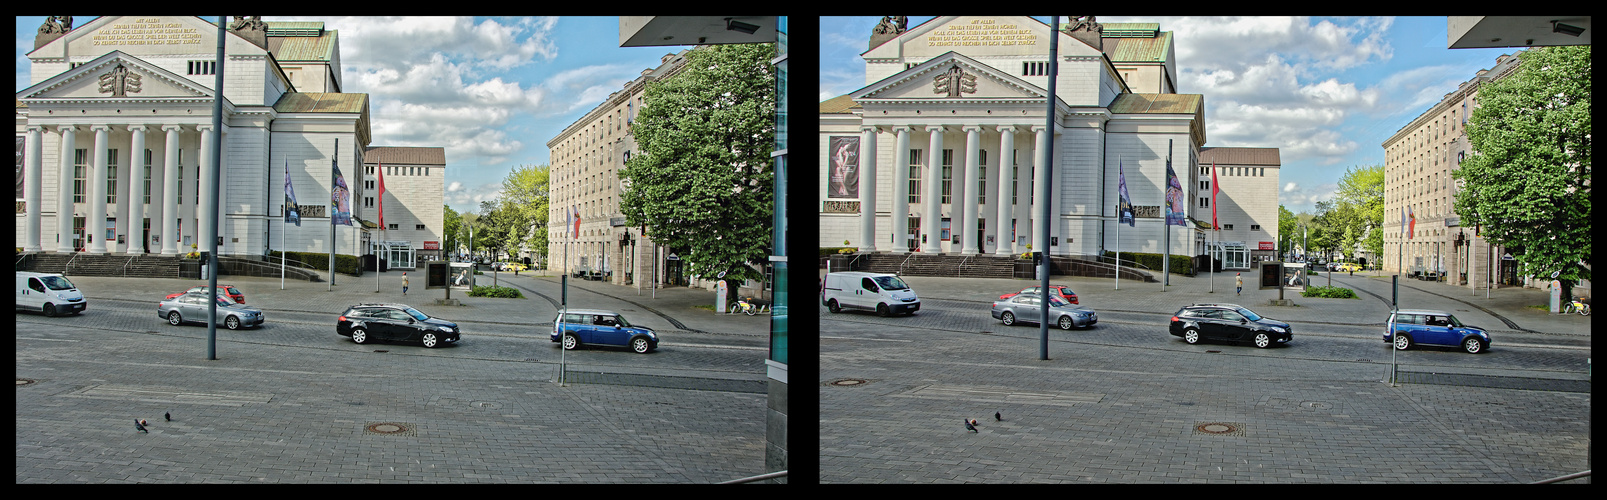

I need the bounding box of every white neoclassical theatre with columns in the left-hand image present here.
[16,16,444,268]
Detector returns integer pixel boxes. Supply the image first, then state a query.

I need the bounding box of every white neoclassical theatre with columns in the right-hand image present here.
[820,16,1278,267]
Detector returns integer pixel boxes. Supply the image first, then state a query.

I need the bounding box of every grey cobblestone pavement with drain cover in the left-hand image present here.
[16,273,768,482]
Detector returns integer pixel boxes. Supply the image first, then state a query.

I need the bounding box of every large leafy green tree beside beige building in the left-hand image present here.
[620,43,776,299]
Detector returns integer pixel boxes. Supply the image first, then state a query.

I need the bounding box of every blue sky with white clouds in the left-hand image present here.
[16,16,689,212]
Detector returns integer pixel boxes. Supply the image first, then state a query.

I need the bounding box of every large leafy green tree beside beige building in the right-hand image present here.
[1453,45,1591,296]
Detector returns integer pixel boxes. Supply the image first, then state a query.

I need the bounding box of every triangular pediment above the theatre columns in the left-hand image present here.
[16,50,212,101]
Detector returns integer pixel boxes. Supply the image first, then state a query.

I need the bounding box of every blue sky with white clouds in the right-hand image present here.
[820,16,1517,214]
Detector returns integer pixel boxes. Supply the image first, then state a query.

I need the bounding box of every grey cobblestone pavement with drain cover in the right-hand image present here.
[818,268,1591,484]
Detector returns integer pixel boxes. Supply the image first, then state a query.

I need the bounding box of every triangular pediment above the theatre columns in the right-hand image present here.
[852,51,1048,101]
